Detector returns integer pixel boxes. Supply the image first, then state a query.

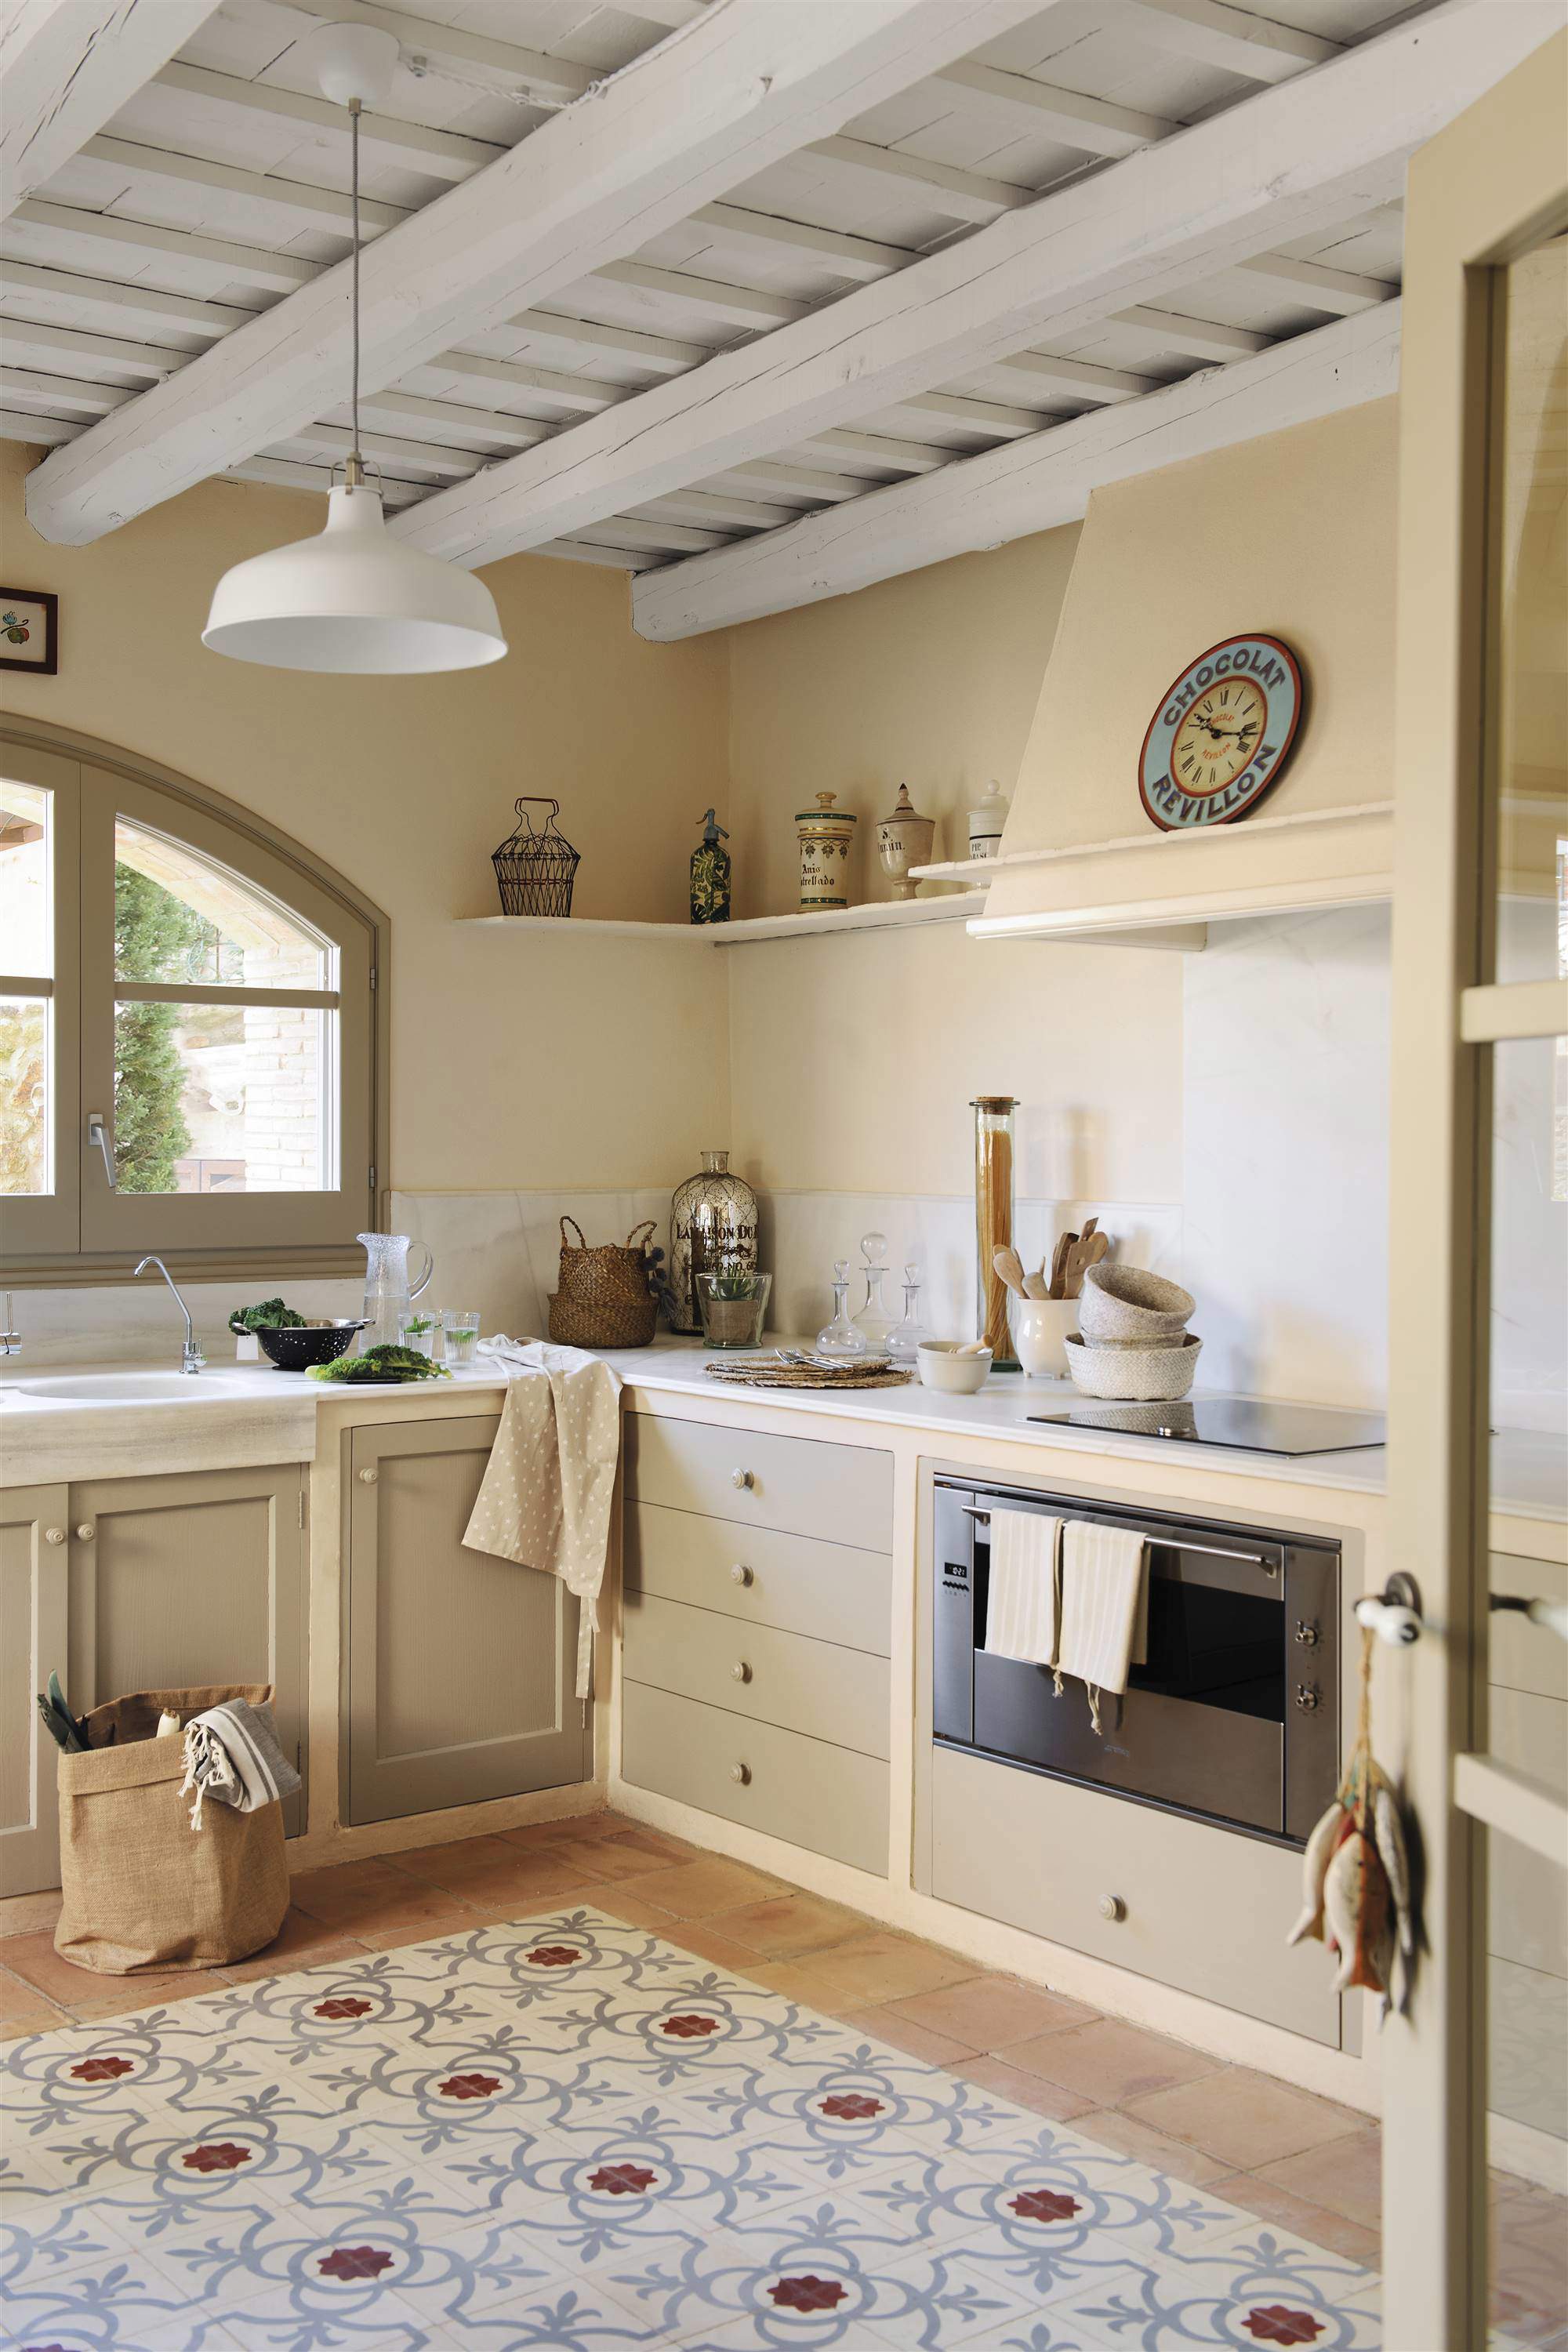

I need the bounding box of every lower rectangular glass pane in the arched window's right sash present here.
[115,1004,336,1192]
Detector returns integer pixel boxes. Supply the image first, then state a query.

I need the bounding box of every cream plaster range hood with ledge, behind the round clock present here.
[926,400,1396,948]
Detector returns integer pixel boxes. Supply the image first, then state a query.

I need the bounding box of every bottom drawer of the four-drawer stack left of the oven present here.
[621,1679,893,1882]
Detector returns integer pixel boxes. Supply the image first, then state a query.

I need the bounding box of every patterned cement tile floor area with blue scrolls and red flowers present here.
[0,1905,1377,2352]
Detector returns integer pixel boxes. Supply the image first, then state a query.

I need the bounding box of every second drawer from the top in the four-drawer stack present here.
[623,1503,893,1658]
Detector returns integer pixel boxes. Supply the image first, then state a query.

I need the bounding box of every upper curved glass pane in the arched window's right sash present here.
[115,818,334,988]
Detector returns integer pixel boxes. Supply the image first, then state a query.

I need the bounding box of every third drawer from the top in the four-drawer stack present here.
[621,1592,888,1757]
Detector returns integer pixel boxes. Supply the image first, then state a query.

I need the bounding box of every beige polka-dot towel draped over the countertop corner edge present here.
[463,1331,621,1698]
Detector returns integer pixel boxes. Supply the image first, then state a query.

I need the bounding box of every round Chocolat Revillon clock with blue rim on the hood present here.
[1138,637,1302,833]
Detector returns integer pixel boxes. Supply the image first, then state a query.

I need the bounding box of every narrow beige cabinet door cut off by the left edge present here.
[0,1486,69,1896]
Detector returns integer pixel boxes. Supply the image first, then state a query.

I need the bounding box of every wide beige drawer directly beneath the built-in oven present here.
[931,1740,1340,2049]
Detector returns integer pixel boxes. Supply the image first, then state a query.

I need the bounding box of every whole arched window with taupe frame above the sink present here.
[0,724,386,1282]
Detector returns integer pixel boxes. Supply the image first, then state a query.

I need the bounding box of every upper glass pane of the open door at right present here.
[1493,238,1568,981]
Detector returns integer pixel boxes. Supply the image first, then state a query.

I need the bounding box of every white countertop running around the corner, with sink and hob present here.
[0,1338,1568,1522]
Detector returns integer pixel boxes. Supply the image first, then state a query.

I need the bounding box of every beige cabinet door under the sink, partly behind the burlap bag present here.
[71,1463,306,1835]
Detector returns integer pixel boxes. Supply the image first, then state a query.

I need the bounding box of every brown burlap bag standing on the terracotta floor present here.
[54,1682,289,1976]
